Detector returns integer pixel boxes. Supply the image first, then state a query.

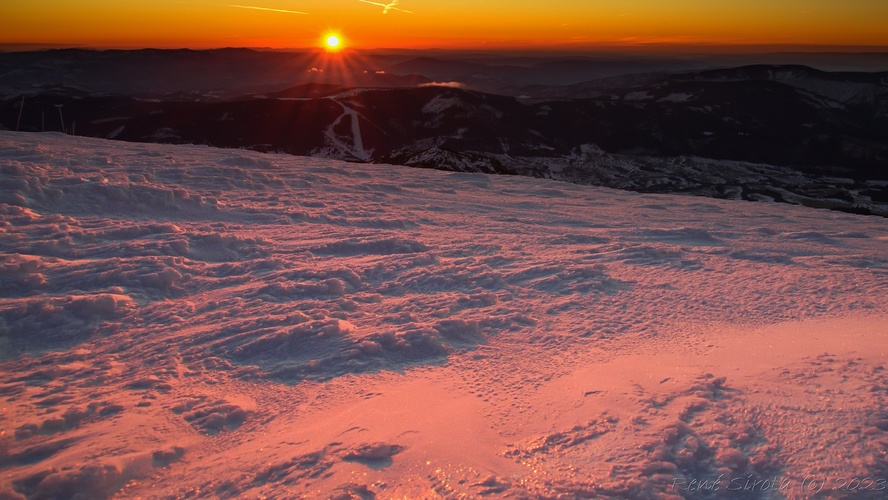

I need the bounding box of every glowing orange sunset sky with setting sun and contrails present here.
[0,0,888,50]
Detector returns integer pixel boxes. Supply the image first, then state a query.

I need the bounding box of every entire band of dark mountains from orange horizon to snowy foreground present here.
[0,49,888,215]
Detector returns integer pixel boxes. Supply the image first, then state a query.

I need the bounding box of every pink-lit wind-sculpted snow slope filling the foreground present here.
[0,131,888,498]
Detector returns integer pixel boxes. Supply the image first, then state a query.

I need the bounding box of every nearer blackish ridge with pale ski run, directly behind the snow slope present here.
[0,51,888,214]
